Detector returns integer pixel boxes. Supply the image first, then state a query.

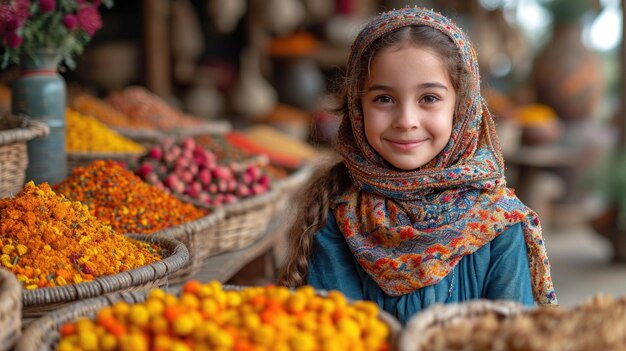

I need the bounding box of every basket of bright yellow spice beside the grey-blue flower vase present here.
[65,108,146,174]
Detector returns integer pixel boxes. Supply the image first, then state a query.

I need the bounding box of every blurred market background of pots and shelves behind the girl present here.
[0,0,626,305]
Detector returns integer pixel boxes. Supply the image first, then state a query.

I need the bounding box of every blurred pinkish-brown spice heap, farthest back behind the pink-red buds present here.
[107,86,204,131]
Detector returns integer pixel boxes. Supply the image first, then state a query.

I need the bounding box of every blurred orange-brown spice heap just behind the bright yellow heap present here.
[70,93,154,129]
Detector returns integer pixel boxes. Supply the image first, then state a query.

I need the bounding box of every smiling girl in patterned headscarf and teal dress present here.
[279,8,557,322]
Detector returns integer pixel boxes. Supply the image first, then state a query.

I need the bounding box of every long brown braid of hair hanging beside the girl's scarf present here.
[277,162,351,287]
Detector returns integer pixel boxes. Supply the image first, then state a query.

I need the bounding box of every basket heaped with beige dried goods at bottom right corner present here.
[399,294,626,351]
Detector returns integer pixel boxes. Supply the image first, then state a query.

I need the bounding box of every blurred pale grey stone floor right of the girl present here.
[544,225,626,306]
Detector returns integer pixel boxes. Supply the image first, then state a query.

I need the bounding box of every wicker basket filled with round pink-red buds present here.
[135,137,280,255]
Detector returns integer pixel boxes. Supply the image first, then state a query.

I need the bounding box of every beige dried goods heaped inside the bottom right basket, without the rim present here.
[416,295,626,351]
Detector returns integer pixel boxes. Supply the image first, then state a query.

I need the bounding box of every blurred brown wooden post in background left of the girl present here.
[143,0,172,98]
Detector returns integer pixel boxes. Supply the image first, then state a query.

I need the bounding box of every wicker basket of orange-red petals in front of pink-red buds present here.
[54,160,225,282]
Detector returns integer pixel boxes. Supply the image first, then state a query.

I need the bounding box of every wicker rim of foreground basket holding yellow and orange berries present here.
[15,285,402,351]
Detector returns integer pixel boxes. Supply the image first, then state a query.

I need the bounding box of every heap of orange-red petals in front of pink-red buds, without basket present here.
[55,160,208,234]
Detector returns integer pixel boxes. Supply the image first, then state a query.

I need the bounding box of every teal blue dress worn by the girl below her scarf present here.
[307,214,535,323]
